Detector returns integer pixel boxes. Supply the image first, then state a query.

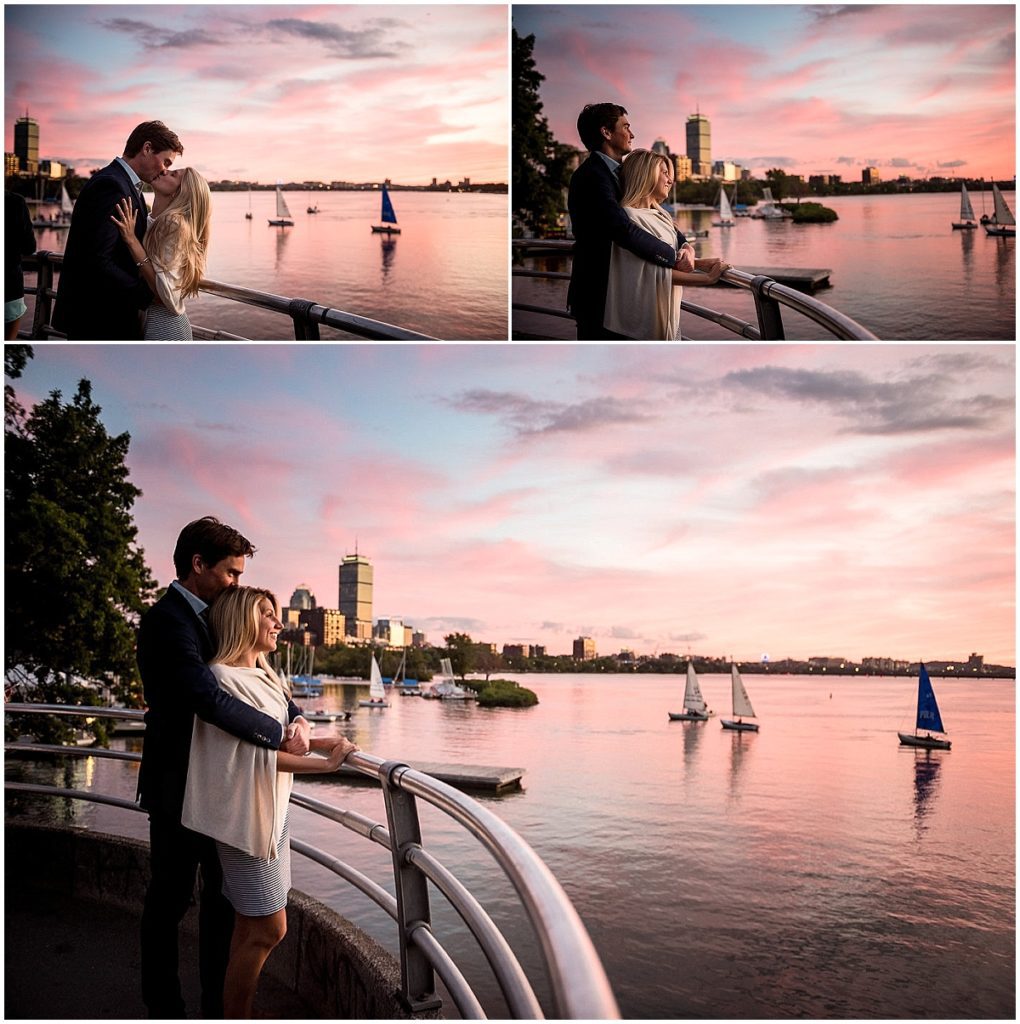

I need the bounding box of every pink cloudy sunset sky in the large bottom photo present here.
[14,343,1015,664]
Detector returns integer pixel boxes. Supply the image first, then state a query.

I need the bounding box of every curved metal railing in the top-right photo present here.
[511,239,878,341]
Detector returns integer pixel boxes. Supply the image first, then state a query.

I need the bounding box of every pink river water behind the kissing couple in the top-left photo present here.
[30,191,508,341]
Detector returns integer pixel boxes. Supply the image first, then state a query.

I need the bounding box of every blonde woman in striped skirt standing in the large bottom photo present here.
[181,587,357,1018]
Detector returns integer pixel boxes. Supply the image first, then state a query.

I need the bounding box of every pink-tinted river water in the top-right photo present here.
[513,193,1017,341]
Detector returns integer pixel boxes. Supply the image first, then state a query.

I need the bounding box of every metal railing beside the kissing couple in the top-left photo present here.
[18,250,435,341]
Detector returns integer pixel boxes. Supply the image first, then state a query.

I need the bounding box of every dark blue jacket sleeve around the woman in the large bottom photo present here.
[138,602,284,750]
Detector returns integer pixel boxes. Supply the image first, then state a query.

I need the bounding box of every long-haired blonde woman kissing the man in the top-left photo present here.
[111,167,212,341]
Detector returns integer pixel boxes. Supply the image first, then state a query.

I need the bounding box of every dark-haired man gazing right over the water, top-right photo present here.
[566,103,694,341]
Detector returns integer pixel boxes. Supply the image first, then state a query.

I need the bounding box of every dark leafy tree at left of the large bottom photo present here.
[4,361,156,737]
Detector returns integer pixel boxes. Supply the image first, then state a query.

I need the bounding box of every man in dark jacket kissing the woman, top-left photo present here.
[53,121,184,341]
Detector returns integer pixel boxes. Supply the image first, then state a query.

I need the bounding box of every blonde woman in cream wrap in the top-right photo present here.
[605,150,730,341]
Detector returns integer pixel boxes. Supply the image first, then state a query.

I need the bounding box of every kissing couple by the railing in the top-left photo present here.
[53,121,211,341]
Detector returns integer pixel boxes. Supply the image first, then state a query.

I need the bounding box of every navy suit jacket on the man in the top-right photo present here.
[566,153,686,325]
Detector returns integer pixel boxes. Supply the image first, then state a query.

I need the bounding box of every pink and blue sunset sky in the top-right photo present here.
[513,4,1016,181]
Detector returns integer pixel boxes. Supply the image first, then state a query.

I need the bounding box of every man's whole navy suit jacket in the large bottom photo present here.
[138,587,300,822]
